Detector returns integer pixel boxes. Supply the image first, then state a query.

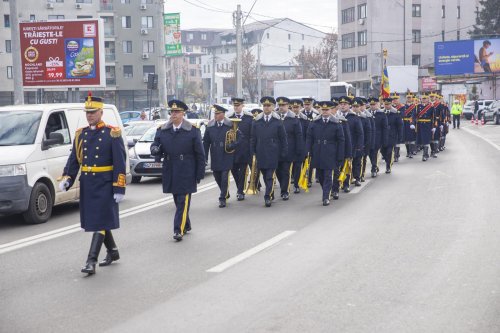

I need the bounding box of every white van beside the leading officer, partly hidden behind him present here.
[0,103,130,224]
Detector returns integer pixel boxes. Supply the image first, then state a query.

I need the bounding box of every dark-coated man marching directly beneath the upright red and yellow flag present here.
[382,97,403,173]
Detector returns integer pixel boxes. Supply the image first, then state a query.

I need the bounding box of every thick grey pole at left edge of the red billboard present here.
[9,1,24,105]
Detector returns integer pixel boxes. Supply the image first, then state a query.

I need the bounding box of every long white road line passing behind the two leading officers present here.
[0,182,217,254]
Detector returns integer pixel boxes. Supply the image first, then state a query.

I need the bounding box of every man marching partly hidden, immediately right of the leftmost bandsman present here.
[227,97,254,201]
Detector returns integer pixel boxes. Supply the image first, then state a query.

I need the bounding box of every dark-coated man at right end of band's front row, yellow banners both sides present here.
[306,101,345,206]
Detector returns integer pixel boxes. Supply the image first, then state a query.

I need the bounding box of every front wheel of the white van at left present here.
[23,183,53,224]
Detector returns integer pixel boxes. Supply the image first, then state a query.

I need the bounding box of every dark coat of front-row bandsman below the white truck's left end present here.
[250,112,288,169]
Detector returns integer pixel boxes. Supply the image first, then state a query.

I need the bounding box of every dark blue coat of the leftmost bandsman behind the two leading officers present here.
[203,119,238,171]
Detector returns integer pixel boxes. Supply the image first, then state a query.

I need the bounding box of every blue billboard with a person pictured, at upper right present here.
[434,39,500,75]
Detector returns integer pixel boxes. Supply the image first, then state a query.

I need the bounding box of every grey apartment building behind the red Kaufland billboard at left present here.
[0,0,164,111]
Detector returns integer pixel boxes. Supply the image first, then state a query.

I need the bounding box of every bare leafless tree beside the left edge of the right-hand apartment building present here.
[294,34,338,81]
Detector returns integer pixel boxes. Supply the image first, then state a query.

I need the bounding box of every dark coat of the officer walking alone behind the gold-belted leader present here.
[151,120,205,194]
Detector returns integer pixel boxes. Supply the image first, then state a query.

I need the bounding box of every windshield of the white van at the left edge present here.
[0,111,42,146]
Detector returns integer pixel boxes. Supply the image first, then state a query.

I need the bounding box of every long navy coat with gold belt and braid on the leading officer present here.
[63,122,127,231]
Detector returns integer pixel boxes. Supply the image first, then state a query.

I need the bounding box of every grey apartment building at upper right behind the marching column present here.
[338,0,480,96]
